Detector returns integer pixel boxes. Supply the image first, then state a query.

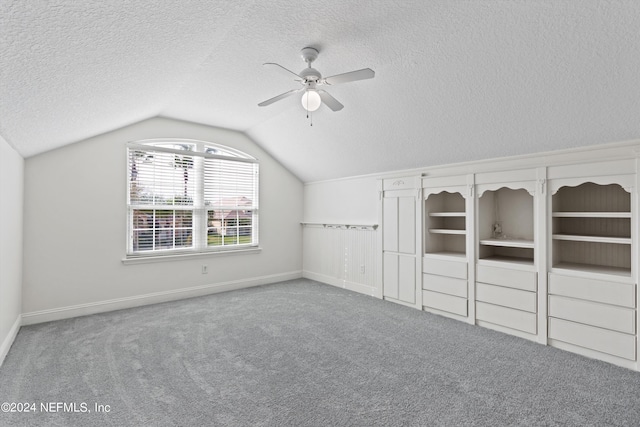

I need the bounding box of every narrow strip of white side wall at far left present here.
[0,137,24,364]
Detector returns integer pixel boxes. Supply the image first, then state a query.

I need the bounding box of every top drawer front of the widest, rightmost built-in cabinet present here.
[549,273,636,308]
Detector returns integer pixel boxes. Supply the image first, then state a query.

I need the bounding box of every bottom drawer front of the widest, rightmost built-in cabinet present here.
[549,317,636,360]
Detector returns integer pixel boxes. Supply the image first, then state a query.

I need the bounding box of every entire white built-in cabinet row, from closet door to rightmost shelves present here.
[381,151,640,370]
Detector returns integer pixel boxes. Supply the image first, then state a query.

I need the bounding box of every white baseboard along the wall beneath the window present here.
[22,271,302,325]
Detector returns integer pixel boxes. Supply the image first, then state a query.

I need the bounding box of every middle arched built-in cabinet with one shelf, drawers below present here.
[475,169,540,339]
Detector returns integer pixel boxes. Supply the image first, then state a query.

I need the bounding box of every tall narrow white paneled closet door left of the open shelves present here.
[382,178,417,304]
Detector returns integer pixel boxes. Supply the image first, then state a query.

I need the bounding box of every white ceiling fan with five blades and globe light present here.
[258,47,375,111]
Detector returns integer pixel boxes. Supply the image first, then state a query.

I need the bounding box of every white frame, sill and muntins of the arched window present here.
[123,138,260,263]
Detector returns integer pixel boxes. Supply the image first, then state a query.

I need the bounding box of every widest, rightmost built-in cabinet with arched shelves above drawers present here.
[548,164,638,365]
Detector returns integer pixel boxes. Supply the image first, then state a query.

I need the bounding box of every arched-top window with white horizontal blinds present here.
[127,139,259,256]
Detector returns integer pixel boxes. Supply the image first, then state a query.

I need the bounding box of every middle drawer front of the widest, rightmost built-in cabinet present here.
[549,295,636,334]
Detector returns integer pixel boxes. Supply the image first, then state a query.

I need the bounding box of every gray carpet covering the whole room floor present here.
[0,280,640,426]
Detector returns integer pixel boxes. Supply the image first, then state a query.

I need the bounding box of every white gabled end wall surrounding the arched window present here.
[23,118,303,323]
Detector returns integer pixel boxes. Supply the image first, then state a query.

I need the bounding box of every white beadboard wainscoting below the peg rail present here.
[302,223,382,297]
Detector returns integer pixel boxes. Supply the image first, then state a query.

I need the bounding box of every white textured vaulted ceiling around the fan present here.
[0,0,640,181]
